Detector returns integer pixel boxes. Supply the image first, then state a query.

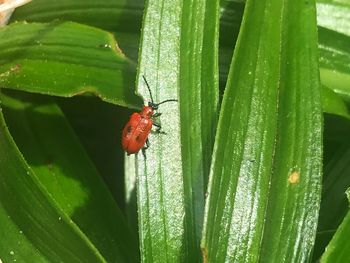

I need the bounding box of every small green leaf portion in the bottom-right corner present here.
[320,189,350,263]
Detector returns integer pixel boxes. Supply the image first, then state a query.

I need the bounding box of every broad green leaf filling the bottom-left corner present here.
[0,99,105,262]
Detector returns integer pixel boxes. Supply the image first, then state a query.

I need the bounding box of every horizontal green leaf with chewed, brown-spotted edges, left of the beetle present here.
[0,21,140,107]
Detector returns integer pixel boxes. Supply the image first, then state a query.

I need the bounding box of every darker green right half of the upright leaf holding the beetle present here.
[179,0,219,262]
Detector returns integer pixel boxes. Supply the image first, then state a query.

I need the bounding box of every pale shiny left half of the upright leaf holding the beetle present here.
[126,0,186,262]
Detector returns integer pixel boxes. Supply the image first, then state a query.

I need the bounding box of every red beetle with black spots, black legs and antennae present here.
[122,76,177,156]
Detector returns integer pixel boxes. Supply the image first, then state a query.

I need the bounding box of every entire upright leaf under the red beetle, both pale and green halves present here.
[126,0,219,262]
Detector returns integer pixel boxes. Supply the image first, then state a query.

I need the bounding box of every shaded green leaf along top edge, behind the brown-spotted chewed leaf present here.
[11,0,144,61]
